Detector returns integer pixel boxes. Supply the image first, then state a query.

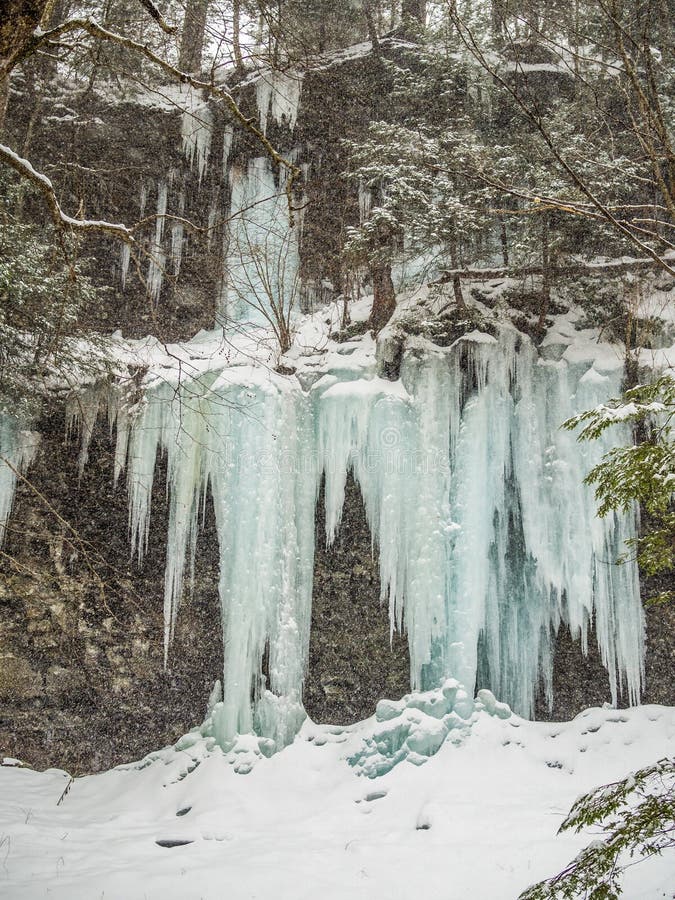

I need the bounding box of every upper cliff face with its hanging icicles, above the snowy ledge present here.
[7,41,405,341]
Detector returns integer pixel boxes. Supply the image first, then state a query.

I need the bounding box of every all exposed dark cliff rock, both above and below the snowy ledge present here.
[0,44,675,773]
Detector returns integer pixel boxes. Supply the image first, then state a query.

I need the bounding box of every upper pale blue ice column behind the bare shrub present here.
[220,157,300,327]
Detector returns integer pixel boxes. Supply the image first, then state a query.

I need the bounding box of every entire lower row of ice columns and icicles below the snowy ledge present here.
[68,327,643,747]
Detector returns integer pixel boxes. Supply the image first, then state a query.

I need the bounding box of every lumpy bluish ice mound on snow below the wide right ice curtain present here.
[347,678,511,778]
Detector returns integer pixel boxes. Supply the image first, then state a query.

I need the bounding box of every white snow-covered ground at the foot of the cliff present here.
[0,706,675,900]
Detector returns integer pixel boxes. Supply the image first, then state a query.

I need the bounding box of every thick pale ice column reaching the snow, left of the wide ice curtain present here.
[211,370,316,746]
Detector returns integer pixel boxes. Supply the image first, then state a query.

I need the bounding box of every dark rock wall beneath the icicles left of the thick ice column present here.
[0,419,222,773]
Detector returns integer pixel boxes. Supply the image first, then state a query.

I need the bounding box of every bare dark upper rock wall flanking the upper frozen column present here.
[7,42,418,341]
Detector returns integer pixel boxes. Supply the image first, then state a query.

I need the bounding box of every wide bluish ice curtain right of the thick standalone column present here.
[314,329,644,715]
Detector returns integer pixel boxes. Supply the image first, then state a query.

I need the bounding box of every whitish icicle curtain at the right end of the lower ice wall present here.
[510,350,644,703]
